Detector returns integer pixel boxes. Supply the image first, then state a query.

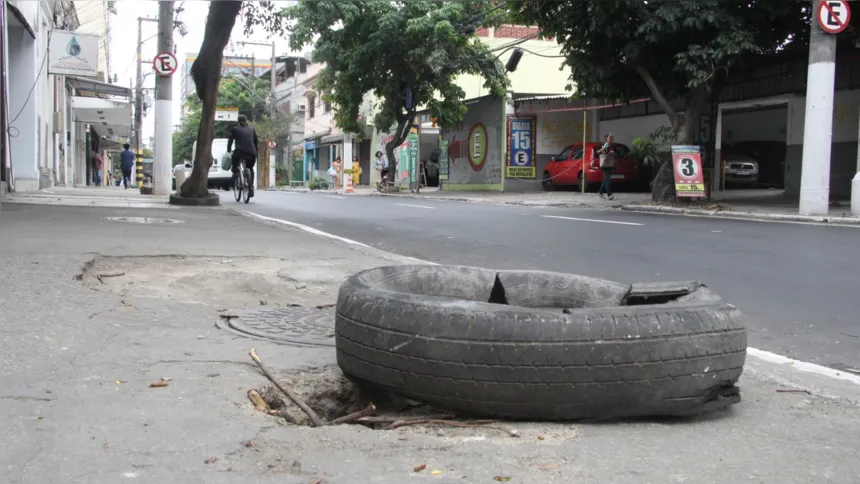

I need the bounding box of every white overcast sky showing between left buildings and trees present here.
[110,0,293,144]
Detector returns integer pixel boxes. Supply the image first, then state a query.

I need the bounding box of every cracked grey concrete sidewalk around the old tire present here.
[0,204,860,484]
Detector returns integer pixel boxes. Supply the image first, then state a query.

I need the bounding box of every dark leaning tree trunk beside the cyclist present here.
[180,0,242,198]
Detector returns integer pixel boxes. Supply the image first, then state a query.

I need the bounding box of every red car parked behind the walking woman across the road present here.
[543,143,639,191]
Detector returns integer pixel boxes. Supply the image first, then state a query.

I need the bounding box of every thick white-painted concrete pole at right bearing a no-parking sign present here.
[800,0,836,215]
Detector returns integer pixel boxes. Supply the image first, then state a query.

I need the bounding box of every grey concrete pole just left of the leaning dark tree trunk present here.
[152,1,173,195]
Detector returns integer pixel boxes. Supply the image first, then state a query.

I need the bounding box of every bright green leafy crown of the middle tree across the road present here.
[278,0,508,172]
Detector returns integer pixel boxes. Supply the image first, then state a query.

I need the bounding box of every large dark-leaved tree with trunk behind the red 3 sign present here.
[508,0,810,200]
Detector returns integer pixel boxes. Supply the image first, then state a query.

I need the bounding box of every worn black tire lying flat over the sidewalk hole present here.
[336,266,747,420]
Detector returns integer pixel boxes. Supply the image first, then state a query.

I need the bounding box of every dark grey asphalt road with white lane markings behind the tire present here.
[222,191,860,371]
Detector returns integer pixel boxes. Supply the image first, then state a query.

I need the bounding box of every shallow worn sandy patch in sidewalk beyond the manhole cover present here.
[76,255,348,308]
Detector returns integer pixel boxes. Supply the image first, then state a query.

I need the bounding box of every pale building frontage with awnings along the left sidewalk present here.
[0,0,131,192]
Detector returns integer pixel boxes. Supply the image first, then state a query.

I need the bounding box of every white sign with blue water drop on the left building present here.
[48,30,99,77]
